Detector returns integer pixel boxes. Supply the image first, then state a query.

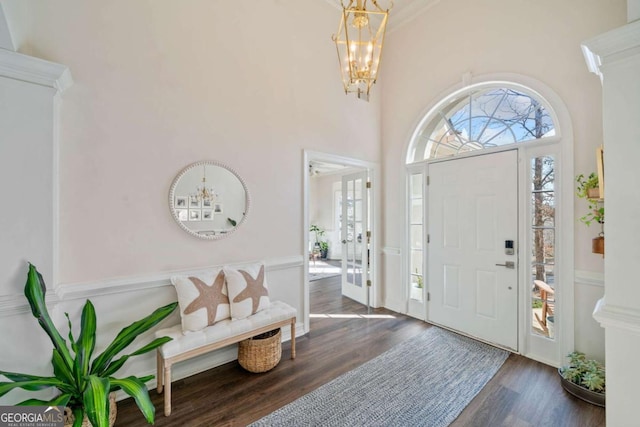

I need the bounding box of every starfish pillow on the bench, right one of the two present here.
[224,264,271,320]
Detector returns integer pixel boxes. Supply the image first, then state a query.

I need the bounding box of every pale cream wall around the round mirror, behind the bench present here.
[0,0,381,404]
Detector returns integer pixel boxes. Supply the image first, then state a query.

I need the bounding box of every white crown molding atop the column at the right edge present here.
[581,21,640,79]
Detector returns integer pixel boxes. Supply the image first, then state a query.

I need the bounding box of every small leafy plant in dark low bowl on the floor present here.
[558,351,605,407]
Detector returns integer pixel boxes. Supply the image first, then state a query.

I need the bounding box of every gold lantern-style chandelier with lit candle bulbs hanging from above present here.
[332,0,393,101]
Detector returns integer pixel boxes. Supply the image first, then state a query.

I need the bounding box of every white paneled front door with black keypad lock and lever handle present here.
[427,150,518,350]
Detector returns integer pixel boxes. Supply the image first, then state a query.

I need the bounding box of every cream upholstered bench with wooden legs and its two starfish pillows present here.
[155,264,297,416]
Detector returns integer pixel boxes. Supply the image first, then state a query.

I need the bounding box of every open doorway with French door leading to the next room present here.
[303,152,377,330]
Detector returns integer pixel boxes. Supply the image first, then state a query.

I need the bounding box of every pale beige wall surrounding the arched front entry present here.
[381,0,626,362]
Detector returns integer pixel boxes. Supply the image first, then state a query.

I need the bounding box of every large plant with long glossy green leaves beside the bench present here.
[0,264,178,427]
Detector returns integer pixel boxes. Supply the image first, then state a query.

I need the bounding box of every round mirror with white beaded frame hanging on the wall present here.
[169,161,249,240]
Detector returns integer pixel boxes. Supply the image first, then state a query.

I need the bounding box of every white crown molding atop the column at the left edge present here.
[0,49,73,92]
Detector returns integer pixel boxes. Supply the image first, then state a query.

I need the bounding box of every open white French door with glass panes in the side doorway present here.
[340,171,369,305]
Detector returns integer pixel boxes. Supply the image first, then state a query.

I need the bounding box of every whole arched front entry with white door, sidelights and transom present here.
[405,76,574,365]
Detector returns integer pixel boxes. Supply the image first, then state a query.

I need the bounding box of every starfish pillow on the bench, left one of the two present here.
[171,269,230,333]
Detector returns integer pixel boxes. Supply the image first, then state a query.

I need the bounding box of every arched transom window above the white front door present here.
[407,85,556,163]
